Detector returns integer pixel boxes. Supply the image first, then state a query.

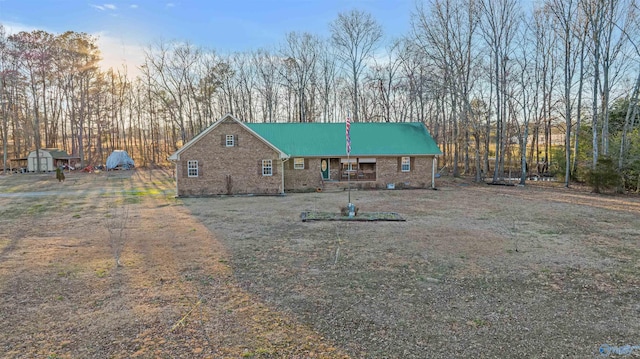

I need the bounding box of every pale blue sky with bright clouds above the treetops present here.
[0,0,415,74]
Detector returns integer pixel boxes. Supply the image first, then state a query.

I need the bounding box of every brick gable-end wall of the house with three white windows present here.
[176,119,282,197]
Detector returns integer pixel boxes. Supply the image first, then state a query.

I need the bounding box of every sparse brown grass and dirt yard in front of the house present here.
[0,170,640,358]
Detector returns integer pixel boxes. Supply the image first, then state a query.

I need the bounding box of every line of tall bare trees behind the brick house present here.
[0,0,640,191]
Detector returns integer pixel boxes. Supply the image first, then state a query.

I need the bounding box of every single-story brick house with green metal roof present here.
[169,115,442,197]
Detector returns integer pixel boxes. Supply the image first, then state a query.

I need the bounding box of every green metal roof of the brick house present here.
[245,122,442,157]
